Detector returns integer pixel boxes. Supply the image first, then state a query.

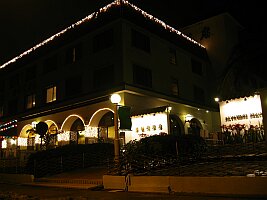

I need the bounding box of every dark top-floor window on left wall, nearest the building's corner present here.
[93,29,114,52]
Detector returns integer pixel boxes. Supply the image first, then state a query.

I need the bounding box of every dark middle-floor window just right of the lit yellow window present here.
[65,77,82,97]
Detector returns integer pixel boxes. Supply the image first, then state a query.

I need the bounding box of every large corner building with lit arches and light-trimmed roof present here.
[0,1,220,156]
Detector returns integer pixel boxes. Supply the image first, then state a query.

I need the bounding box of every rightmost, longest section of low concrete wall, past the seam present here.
[170,176,267,196]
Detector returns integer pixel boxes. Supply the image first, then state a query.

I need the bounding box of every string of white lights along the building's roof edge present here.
[0,0,205,69]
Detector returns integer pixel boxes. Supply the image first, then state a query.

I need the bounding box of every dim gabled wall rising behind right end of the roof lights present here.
[182,13,244,78]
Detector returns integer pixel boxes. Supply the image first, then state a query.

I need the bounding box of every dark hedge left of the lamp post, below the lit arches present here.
[26,143,114,177]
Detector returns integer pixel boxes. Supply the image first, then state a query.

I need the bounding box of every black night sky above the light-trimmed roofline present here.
[0,0,266,64]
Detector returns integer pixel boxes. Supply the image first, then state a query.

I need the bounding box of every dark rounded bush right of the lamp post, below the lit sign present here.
[121,134,207,173]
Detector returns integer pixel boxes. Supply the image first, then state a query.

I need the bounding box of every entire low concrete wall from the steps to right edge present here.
[103,175,267,197]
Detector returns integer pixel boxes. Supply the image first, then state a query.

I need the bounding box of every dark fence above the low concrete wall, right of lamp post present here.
[109,142,267,176]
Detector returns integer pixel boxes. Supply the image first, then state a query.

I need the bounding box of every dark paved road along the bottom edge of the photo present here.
[0,183,261,200]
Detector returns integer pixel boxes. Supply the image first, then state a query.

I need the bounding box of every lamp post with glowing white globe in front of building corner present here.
[110,94,121,164]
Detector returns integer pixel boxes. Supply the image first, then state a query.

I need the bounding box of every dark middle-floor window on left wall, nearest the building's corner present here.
[94,65,114,88]
